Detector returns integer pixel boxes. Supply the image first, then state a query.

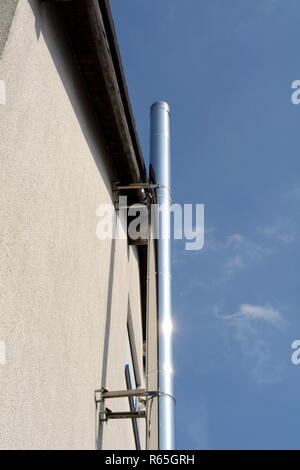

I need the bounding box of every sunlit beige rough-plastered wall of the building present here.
[0,0,143,449]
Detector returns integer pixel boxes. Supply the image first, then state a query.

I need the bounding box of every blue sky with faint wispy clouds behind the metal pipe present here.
[111,0,300,449]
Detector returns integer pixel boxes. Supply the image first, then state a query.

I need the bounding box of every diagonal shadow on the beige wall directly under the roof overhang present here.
[28,0,112,193]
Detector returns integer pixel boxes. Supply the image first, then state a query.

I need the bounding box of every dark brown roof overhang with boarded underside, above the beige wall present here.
[55,0,147,194]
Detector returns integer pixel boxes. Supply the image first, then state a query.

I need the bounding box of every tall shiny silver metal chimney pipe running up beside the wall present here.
[150,101,175,450]
